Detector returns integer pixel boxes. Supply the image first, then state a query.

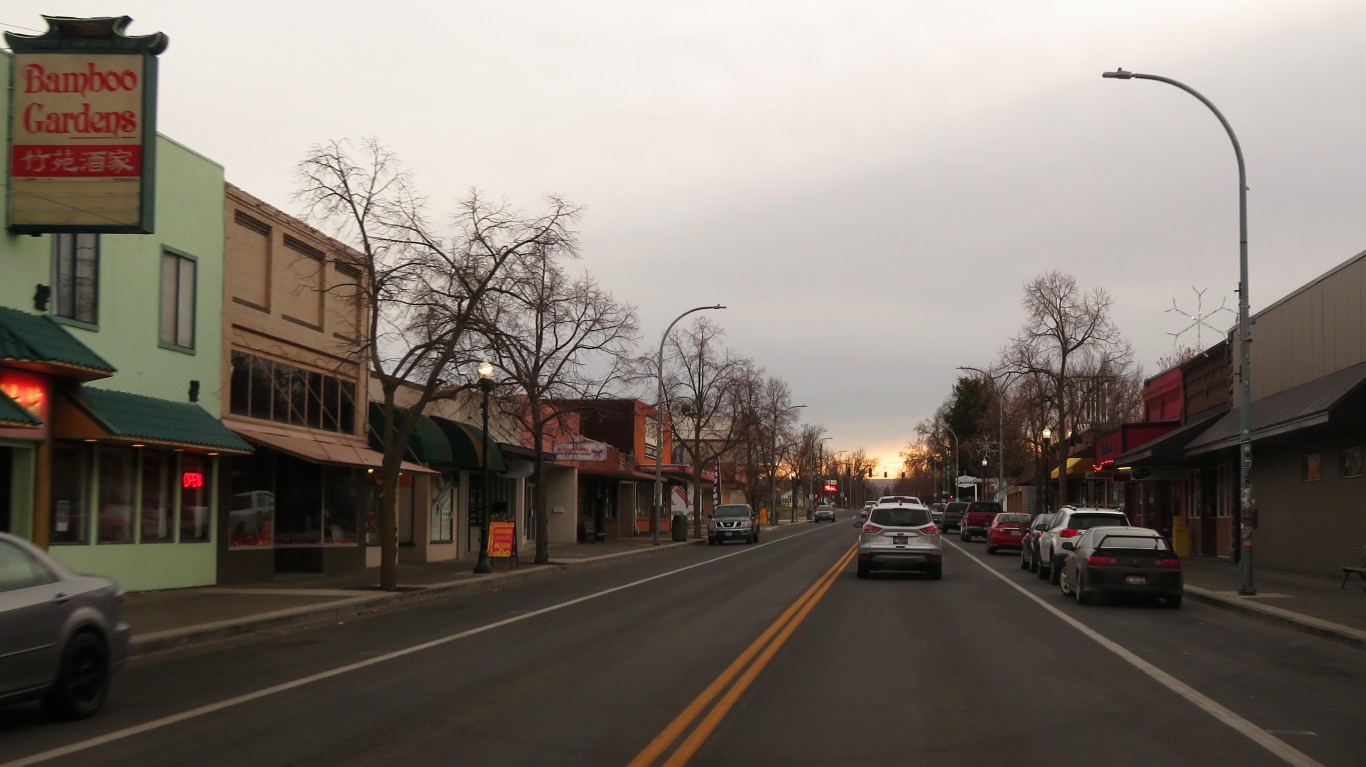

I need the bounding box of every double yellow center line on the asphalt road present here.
[630,547,858,767]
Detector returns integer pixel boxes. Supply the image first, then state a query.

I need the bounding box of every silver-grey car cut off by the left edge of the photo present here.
[0,533,128,719]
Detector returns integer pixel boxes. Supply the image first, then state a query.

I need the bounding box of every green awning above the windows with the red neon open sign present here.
[53,387,251,454]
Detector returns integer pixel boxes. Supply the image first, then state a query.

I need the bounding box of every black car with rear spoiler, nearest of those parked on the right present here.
[1057,526,1186,608]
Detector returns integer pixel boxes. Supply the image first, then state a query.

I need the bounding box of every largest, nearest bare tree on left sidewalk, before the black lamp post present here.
[296,139,579,589]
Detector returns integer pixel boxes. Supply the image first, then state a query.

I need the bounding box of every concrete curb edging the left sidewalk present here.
[128,539,693,659]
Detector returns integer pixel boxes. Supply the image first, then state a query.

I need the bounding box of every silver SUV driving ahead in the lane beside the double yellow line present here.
[856,503,944,581]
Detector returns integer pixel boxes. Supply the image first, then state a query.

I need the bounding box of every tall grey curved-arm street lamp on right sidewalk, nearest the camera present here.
[1101,68,1257,596]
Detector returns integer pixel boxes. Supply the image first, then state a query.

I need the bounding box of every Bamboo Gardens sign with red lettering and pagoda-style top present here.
[4,16,167,234]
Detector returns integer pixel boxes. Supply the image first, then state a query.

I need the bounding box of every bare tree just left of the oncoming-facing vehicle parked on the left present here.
[663,317,753,537]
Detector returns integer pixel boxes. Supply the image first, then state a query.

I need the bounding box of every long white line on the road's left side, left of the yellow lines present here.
[0,528,816,767]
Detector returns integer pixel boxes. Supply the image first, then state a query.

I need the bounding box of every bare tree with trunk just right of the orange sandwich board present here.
[481,251,639,565]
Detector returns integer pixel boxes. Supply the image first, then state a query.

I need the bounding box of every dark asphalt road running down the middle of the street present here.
[0,511,1366,767]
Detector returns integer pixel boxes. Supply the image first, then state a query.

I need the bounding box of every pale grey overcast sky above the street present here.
[0,0,1366,469]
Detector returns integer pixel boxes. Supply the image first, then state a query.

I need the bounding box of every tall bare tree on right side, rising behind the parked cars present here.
[1001,271,1134,503]
